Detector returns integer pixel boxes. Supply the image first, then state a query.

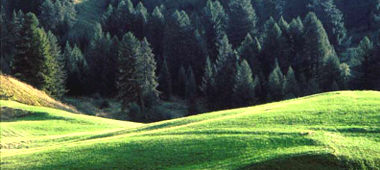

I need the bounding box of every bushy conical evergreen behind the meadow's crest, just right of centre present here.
[233,60,258,107]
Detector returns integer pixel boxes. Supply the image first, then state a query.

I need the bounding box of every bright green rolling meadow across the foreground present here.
[1,92,380,169]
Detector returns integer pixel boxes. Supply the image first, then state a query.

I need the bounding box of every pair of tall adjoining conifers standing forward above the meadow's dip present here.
[117,32,158,119]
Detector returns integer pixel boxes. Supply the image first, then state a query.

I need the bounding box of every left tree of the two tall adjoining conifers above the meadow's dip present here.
[117,32,141,111]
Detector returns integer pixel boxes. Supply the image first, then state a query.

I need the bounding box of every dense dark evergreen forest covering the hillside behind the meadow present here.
[0,0,380,121]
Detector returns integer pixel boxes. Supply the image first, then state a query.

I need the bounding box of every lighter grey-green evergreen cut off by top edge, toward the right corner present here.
[309,0,347,45]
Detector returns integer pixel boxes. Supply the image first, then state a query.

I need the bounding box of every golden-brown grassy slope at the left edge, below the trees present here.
[0,74,77,112]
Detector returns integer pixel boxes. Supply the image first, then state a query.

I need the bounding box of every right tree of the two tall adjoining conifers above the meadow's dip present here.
[134,38,158,119]
